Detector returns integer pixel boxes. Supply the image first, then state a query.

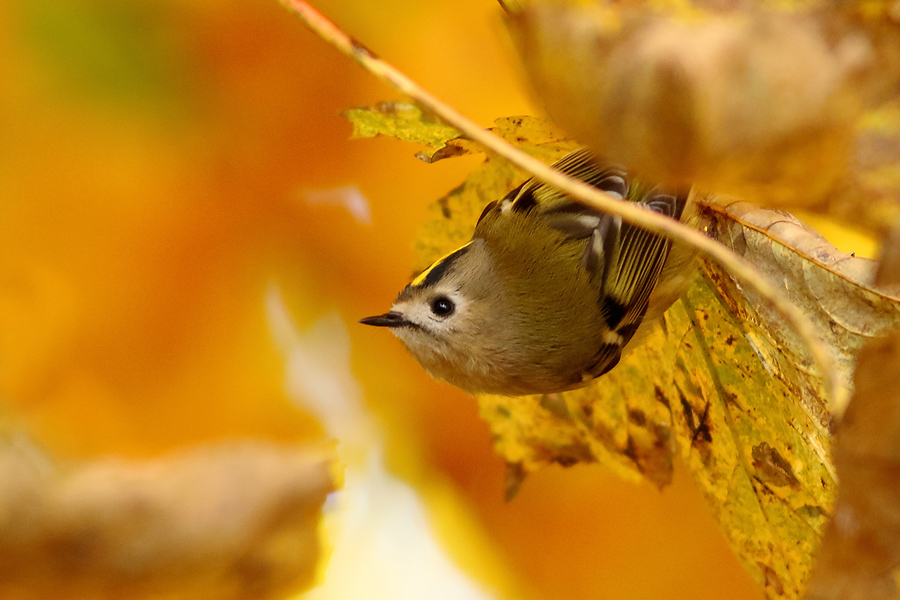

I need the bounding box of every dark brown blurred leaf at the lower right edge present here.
[807,236,900,600]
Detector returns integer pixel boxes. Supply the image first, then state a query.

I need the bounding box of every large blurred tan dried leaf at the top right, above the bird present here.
[509,2,900,207]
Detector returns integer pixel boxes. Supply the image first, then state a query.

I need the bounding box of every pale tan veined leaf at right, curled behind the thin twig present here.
[704,199,900,420]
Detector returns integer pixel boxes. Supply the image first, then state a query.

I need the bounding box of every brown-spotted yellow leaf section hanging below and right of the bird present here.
[423,164,834,597]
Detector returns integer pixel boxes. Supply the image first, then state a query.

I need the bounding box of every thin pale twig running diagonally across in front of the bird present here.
[280,0,849,408]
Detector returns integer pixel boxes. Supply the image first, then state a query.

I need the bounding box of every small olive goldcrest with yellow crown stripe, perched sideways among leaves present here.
[360,149,693,396]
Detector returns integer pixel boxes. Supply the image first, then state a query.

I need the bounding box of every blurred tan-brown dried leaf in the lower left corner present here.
[0,438,332,600]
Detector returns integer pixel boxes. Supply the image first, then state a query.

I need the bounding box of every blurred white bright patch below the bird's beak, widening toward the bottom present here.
[266,286,493,600]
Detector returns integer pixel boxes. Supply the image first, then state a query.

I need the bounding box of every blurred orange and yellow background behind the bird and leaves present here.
[0,0,761,600]
